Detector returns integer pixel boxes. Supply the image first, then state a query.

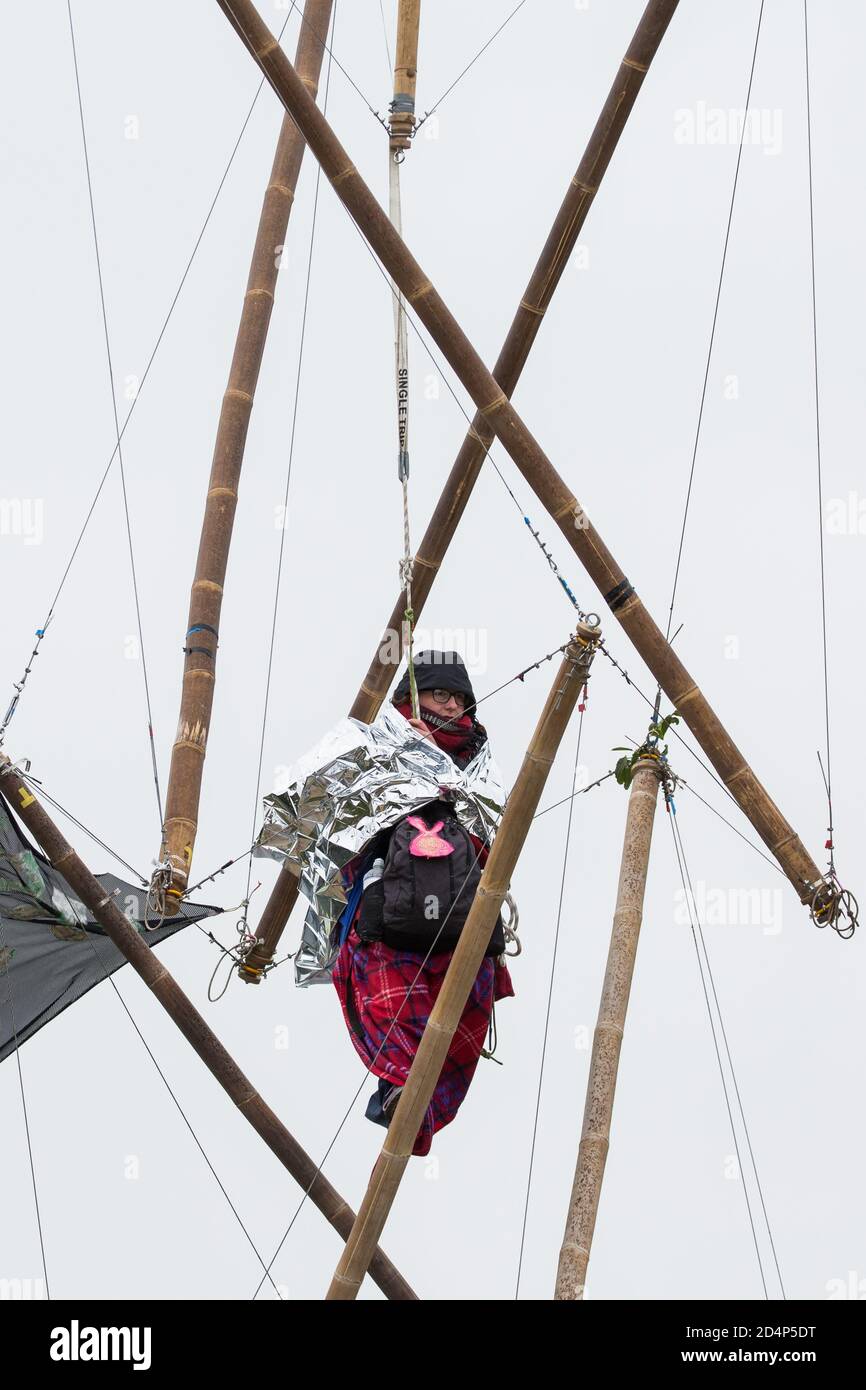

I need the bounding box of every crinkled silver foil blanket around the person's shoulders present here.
[254,705,506,986]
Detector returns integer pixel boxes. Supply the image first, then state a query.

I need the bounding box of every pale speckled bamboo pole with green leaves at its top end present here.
[553,758,660,1301]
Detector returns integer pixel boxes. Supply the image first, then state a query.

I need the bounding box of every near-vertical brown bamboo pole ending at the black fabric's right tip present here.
[160,0,334,912]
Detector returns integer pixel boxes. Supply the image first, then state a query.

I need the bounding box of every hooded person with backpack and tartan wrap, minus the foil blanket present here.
[332,652,514,1155]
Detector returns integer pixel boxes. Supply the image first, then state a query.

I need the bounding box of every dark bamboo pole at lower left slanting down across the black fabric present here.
[0,753,416,1300]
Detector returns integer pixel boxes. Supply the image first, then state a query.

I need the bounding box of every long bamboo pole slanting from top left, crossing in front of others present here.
[217,0,837,928]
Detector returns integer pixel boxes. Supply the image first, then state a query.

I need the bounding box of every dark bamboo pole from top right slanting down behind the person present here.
[239,0,678,984]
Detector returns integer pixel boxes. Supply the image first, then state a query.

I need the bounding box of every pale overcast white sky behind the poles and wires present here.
[0,0,866,1300]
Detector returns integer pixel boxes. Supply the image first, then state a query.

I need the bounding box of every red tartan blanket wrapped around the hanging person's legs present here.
[334,927,514,1155]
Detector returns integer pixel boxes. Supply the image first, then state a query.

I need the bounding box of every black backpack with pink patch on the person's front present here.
[356,802,505,956]
